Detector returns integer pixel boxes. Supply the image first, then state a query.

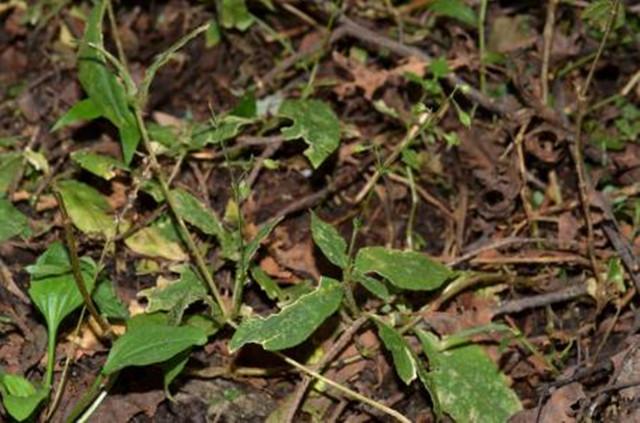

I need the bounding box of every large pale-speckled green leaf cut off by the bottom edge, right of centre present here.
[416,330,522,423]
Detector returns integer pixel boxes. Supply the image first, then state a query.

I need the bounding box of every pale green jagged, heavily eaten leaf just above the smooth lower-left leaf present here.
[138,266,207,325]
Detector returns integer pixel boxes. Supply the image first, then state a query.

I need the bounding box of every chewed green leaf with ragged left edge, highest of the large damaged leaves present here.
[278,100,340,169]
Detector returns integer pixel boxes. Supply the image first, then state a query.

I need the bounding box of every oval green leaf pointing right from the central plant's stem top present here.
[355,247,454,291]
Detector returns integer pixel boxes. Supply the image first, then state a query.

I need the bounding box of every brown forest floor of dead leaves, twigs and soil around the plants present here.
[0,0,640,422]
